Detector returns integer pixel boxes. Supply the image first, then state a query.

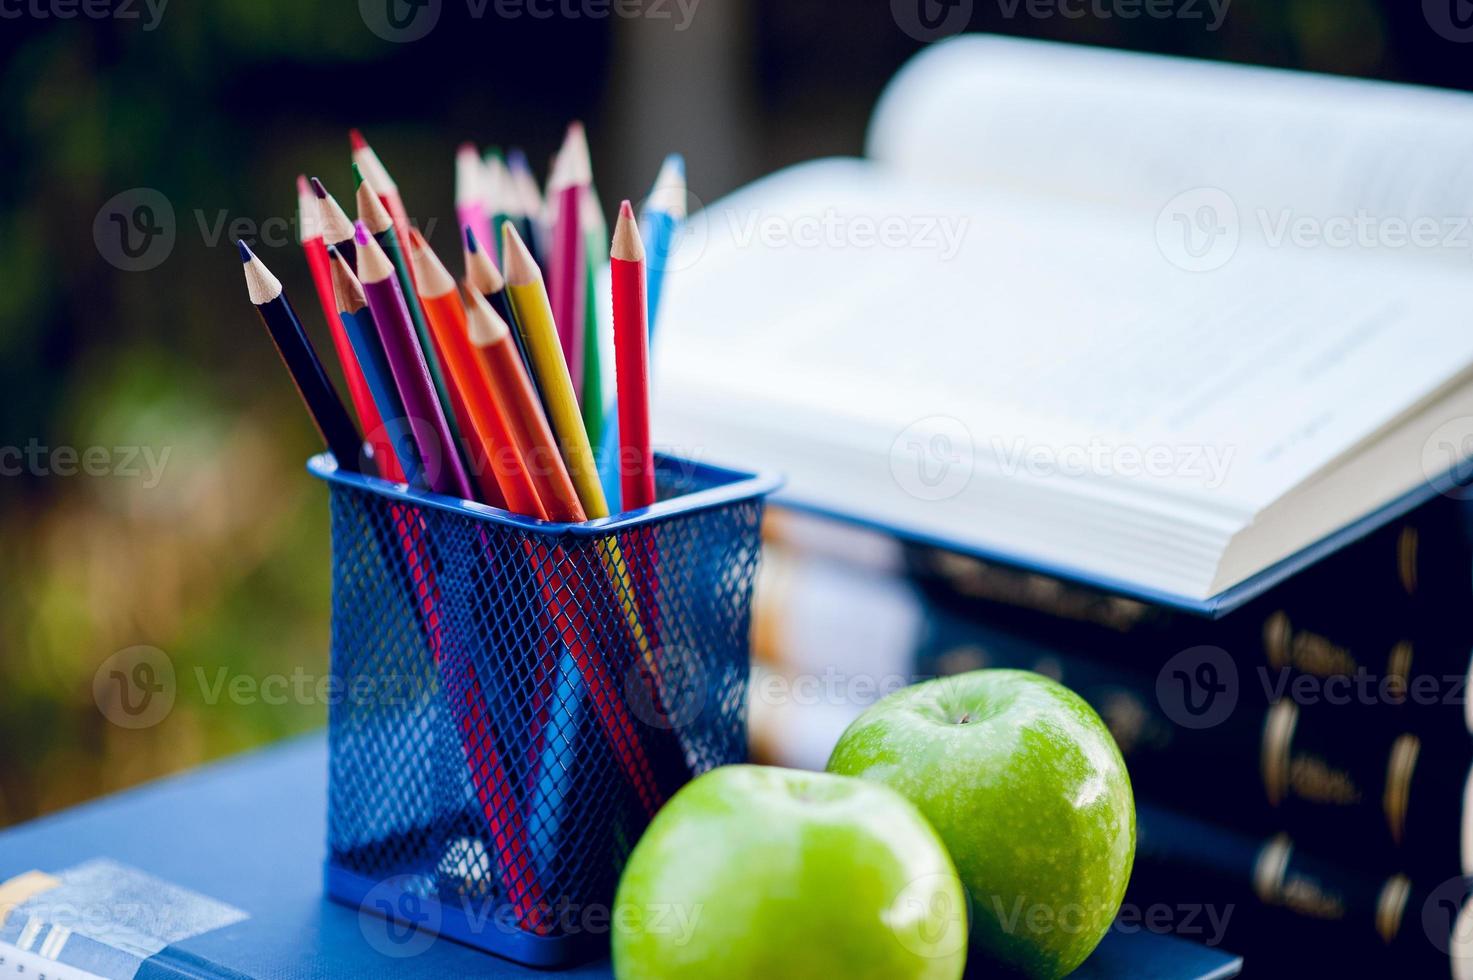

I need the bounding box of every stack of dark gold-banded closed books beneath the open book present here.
[751,500,1473,976]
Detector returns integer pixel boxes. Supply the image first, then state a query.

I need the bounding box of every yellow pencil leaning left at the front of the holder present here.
[502,224,608,519]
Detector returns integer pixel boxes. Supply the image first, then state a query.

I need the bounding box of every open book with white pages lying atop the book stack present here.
[655,37,1473,606]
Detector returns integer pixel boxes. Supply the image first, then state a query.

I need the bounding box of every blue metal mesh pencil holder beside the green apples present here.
[309,455,776,967]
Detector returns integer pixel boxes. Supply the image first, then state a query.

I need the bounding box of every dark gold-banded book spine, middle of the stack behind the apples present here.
[916,615,1473,875]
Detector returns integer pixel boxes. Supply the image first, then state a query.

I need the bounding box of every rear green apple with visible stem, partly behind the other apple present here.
[828,671,1136,977]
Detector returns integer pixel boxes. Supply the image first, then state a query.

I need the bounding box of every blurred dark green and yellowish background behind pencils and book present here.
[0,0,1473,825]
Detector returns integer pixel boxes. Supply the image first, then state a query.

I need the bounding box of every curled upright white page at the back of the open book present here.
[869,35,1473,267]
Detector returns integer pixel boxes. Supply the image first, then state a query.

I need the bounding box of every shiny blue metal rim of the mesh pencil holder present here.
[306,452,784,538]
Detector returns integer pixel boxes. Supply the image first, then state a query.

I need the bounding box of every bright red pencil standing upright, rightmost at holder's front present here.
[610,200,655,510]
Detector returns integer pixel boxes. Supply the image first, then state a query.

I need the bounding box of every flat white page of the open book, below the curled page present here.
[655,161,1473,518]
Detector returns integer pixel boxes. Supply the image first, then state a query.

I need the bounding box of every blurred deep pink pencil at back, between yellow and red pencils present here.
[547,122,591,394]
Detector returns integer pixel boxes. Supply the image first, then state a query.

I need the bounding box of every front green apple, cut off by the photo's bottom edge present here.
[613,766,966,980]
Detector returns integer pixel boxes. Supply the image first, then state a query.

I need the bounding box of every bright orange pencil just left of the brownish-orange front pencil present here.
[409,228,515,506]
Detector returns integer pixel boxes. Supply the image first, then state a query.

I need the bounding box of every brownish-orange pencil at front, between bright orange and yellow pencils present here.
[465,282,588,523]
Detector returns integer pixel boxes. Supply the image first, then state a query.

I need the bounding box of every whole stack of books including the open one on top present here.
[654,37,1473,976]
